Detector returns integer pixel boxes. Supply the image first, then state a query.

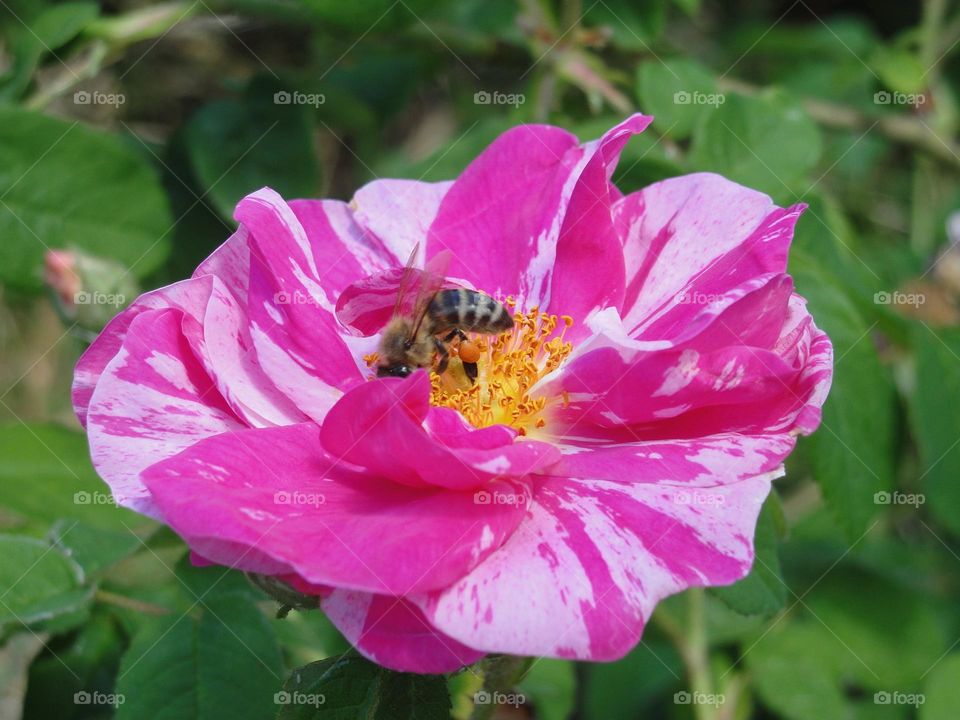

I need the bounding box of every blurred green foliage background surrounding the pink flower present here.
[0,0,960,720]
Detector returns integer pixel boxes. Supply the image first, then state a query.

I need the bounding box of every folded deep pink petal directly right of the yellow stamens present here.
[540,275,831,442]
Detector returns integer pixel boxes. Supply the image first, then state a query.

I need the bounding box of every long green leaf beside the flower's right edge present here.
[791,253,896,542]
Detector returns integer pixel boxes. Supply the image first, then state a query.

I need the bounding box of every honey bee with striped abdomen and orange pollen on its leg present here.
[377,246,513,383]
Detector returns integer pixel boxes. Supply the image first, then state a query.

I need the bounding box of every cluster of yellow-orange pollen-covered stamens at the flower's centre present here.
[430,298,573,435]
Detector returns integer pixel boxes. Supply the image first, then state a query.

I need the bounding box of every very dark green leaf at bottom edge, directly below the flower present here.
[277,655,450,720]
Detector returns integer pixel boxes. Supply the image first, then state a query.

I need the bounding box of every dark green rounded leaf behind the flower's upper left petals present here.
[185,81,325,217]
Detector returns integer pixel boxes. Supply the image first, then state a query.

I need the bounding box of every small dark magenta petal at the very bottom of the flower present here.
[322,590,483,674]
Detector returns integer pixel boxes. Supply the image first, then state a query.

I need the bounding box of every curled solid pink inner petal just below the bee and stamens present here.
[321,371,560,490]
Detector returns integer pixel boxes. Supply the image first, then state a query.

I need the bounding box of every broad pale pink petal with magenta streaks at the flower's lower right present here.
[417,473,775,661]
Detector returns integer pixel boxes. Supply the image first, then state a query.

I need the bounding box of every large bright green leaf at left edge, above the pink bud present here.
[0,107,173,291]
